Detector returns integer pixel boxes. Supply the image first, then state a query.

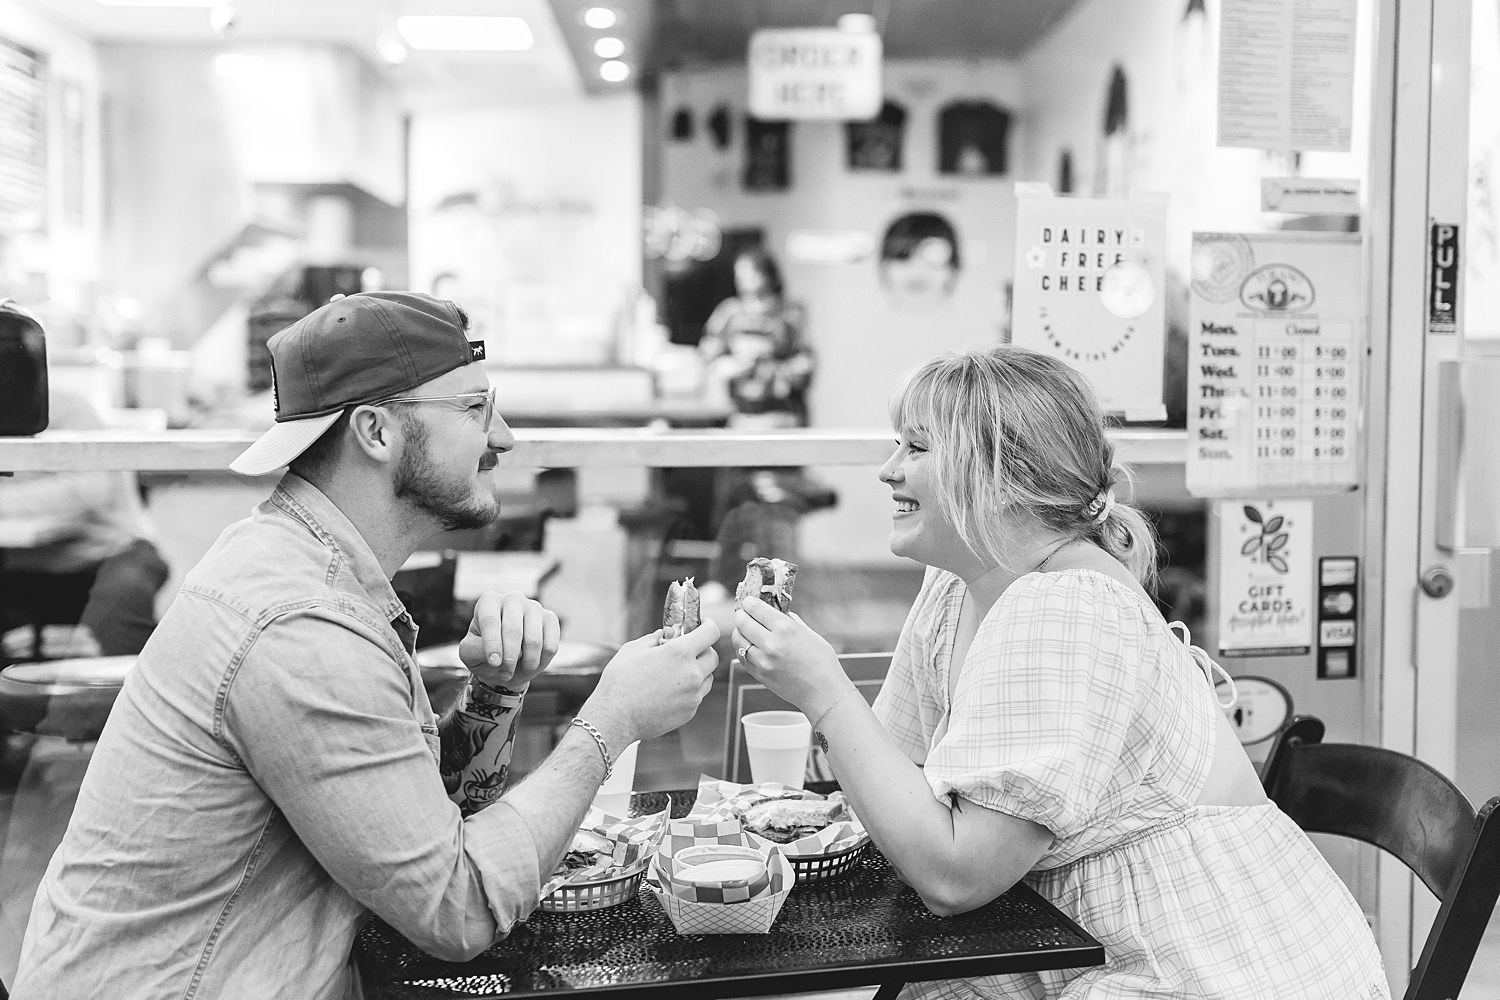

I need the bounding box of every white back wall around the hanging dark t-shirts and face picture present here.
[660,60,1022,565]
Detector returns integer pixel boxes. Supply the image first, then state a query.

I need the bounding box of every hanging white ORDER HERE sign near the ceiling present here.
[747,28,881,121]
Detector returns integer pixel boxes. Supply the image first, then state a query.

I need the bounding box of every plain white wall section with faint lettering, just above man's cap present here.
[408,94,641,363]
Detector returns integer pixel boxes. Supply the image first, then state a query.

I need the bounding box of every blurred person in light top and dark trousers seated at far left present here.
[0,385,168,664]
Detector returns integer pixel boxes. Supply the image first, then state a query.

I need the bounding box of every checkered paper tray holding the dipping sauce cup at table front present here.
[645,819,797,934]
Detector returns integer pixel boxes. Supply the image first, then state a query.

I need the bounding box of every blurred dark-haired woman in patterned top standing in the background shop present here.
[699,249,815,427]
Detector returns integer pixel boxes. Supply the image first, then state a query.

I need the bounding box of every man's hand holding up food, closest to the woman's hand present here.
[578,621,719,748]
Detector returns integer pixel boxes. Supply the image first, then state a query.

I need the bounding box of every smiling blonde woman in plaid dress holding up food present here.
[735,346,1389,1000]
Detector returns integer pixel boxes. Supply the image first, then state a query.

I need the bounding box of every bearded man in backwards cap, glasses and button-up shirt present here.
[12,292,719,1000]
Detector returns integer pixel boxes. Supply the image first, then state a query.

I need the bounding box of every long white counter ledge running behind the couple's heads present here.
[0,427,1187,472]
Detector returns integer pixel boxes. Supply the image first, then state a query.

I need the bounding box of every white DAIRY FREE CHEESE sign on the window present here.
[1011,189,1167,420]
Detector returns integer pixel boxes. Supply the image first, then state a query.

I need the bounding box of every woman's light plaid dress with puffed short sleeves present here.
[875,570,1389,1000]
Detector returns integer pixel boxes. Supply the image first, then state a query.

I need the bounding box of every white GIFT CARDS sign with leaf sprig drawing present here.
[1214,499,1313,658]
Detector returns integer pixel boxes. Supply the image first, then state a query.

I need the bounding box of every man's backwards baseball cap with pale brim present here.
[230,292,485,475]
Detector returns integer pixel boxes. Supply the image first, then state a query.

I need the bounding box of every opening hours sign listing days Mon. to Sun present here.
[1187,232,1365,496]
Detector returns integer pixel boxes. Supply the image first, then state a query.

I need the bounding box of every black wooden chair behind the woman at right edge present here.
[1262,715,1500,1000]
